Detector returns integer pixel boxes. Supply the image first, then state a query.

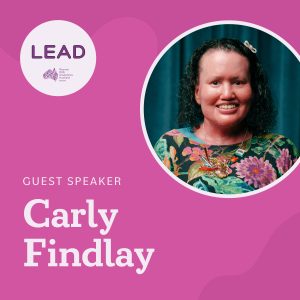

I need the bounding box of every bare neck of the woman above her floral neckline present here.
[195,121,252,145]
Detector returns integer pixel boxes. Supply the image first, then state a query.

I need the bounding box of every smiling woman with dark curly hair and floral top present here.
[155,39,299,194]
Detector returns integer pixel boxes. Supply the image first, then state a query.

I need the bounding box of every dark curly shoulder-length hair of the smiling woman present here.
[178,38,276,134]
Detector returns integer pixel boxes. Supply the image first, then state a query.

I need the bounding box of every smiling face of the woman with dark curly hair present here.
[195,49,252,129]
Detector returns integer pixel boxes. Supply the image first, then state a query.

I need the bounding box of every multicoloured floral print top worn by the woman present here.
[154,128,299,194]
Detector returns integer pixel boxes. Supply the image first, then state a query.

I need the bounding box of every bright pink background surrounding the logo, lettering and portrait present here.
[0,0,300,300]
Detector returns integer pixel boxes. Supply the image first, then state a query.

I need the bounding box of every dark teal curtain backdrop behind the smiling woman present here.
[144,25,300,149]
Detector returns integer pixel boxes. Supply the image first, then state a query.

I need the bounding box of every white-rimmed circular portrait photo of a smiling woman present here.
[141,21,300,198]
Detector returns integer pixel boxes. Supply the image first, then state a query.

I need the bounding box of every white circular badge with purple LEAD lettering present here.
[20,20,96,96]
